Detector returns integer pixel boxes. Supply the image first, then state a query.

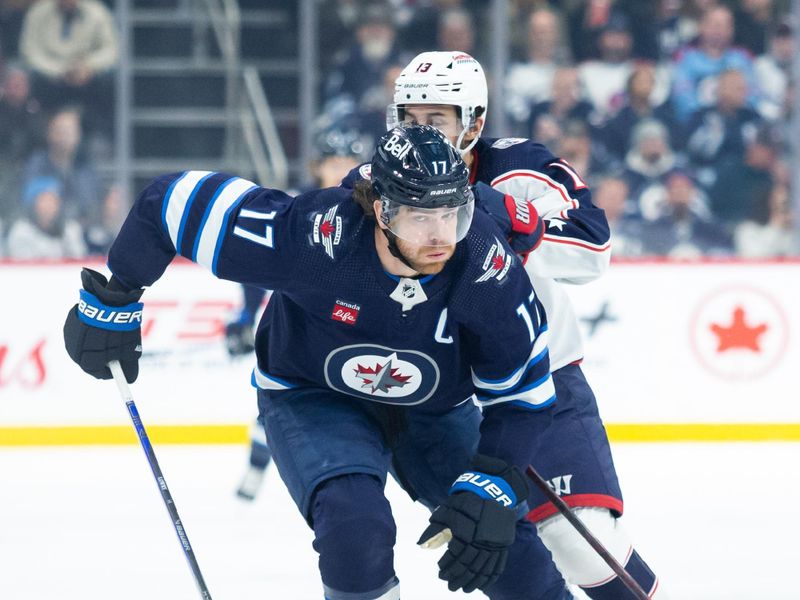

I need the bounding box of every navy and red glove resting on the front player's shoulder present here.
[473,183,544,256]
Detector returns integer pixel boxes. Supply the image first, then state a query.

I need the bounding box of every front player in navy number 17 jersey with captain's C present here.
[64,127,571,600]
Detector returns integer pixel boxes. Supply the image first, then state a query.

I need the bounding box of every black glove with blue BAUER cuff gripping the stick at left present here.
[64,269,144,383]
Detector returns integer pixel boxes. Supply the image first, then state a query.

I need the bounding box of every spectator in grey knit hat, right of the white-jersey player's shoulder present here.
[624,119,678,218]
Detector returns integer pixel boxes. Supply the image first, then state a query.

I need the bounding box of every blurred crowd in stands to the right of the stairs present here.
[320,0,800,258]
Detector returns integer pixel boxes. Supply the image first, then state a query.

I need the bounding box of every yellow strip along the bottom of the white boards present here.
[0,423,800,447]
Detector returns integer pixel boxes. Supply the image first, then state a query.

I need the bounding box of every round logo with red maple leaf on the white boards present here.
[690,285,789,380]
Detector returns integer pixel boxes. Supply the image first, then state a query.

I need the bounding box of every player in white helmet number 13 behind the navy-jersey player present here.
[366,51,666,600]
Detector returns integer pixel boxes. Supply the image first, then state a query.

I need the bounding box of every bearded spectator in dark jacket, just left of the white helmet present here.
[324,2,404,127]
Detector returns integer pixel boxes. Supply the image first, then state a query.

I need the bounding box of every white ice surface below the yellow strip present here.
[0,438,800,600]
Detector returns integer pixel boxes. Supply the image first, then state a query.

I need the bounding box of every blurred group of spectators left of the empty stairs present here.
[0,0,120,259]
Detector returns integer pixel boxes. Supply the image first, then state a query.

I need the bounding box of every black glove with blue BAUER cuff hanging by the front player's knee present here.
[417,454,528,593]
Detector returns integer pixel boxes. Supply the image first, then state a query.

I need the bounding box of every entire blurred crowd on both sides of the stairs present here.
[0,0,800,258]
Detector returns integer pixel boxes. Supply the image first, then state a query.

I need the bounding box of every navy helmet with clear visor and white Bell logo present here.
[372,125,475,246]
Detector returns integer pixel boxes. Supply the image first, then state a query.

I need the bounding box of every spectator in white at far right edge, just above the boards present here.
[734,185,800,258]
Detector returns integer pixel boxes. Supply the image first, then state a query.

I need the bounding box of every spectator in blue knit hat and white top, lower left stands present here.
[7,177,86,259]
